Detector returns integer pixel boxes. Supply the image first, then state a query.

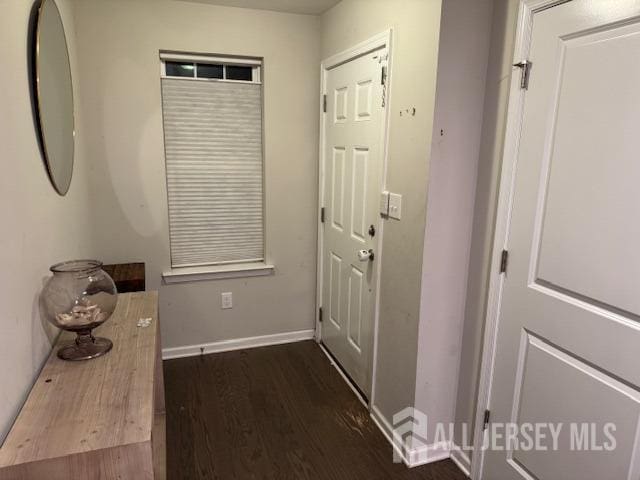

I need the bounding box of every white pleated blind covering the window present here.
[162,78,264,267]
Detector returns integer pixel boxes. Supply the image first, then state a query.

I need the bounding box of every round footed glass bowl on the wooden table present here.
[41,260,118,360]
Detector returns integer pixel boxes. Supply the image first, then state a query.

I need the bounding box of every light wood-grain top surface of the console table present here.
[0,291,159,467]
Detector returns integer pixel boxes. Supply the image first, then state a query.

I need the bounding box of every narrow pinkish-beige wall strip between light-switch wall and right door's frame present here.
[415,0,493,441]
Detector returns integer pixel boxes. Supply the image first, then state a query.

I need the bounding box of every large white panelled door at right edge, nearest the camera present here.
[482,0,640,480]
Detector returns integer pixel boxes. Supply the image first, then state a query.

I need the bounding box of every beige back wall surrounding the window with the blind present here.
[76,0,320,348]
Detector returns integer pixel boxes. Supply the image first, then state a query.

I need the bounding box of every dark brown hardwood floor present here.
[164,341,466,480]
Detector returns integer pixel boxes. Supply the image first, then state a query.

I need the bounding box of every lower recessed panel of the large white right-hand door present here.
[510,330,640,480]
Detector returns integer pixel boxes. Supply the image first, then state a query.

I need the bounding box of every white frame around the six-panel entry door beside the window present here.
[315,28,393,408]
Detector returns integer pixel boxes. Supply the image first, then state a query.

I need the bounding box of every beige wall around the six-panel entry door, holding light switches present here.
[322,0,441,421]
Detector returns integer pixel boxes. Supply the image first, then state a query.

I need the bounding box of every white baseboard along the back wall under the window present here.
[162,330,316,360]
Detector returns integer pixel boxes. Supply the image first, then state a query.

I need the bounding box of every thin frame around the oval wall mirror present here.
[33,0,76,196]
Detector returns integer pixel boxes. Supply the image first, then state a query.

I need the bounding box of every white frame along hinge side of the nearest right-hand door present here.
[471,0,571,480]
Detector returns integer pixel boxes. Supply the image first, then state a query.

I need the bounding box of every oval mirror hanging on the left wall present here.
[35,0,75,195]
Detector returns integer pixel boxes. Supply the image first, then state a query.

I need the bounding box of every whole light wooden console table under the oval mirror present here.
[0,292,165,480]
